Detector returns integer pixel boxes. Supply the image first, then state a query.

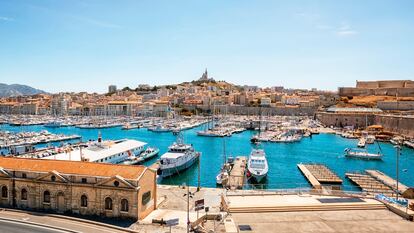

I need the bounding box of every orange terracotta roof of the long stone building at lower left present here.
[0,157,146,180]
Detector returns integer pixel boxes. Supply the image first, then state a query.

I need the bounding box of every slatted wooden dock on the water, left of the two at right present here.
[298,164,342,189]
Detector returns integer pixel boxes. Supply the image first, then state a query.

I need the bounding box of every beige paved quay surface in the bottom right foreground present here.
[230,210,414,233]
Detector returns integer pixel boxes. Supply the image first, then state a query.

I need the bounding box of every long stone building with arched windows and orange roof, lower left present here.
[0,157,157,220]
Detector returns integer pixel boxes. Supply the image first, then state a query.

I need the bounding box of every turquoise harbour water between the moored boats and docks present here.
[0,125,414,190]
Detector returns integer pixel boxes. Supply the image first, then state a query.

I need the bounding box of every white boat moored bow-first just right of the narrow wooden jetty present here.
[247,149,269,182]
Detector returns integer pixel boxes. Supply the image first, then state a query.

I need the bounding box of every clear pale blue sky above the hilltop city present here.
[0,0,414,93]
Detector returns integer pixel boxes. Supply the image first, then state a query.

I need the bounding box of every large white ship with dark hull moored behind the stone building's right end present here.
[157,134,201,178]
